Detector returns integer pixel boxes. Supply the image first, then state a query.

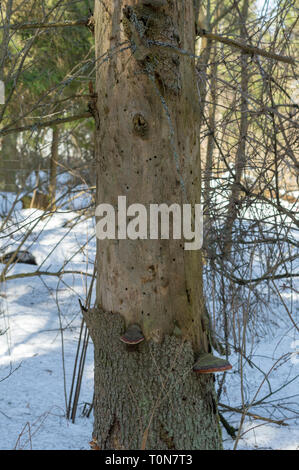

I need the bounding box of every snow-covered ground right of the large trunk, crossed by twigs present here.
[218,317,299,450]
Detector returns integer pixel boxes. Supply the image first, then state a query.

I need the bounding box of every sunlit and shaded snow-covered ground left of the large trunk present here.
[0,196,95,449]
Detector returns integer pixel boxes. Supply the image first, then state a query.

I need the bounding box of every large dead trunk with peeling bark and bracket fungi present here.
[86,0,221,449]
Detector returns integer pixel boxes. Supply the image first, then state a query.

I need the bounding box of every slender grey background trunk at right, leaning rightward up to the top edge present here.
[223,0,248,258]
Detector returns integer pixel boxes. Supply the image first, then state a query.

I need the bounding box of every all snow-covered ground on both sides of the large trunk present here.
[0,189,299,450]
